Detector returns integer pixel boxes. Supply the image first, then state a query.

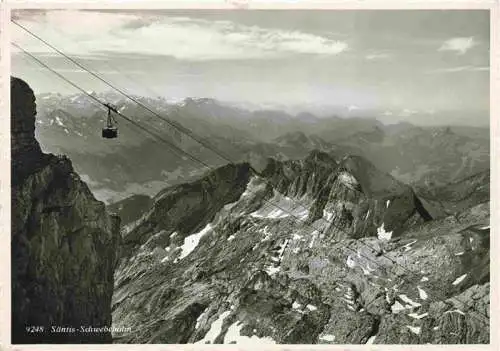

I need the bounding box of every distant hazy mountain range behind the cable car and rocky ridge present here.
[36,93,490,203]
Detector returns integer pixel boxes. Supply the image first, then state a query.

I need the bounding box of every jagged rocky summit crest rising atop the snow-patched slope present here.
[263,151,432,239]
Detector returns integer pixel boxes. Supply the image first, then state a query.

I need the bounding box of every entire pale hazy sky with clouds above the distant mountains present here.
[12,10,489,124]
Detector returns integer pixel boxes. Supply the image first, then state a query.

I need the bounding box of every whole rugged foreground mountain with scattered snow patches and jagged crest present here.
[113,152,490,345]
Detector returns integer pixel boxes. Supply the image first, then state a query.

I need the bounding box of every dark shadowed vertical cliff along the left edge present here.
[11,78,120,344]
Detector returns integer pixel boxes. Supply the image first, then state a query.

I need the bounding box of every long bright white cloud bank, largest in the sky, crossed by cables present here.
[13,10,348,61]
